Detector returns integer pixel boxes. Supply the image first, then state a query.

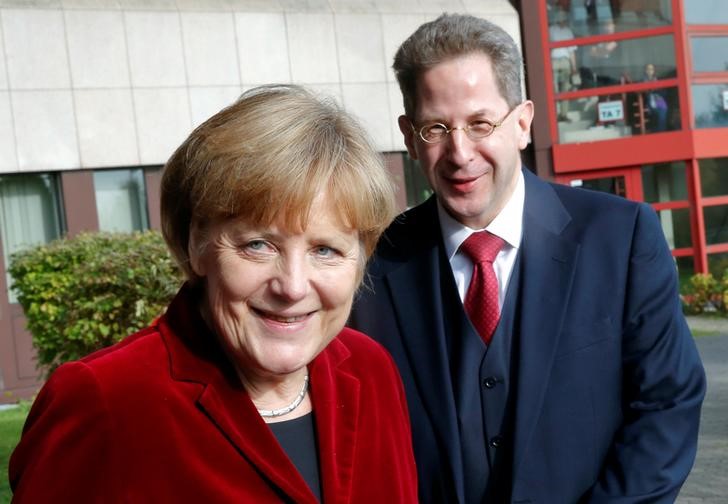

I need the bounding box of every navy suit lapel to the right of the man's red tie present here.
[513,170,579,477]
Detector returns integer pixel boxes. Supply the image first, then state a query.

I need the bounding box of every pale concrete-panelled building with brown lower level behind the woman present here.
[0,0,520,402]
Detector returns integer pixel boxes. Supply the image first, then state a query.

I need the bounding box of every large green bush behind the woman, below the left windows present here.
[10,231,182,372]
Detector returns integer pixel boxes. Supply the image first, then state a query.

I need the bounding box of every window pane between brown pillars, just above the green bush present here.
[94,169,149,232]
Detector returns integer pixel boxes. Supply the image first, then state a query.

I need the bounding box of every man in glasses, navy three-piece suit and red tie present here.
[351,15,705,503]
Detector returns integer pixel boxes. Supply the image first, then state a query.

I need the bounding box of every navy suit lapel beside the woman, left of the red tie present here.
[385,199,464,501]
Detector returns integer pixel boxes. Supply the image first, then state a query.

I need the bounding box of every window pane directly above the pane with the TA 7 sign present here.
[577,35,677,88]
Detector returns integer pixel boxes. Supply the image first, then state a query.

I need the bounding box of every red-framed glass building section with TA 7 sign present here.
[520,0,728,279]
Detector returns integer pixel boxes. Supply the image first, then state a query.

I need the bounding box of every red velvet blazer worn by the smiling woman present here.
[9,288,417,503]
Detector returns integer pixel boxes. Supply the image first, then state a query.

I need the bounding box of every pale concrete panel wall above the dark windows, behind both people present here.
[0,0,520,173]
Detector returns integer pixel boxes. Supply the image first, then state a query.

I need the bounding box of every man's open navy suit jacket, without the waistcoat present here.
[351,170,705,503]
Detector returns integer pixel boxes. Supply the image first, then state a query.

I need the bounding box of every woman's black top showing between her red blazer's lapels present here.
[268,413,321,502]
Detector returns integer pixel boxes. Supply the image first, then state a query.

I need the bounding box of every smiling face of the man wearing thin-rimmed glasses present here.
[399,53,533,229]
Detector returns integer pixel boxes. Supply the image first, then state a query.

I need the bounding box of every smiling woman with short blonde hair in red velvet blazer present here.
[9,86,417,503]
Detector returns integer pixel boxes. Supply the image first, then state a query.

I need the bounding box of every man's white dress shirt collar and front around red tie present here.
[437,173,526,310]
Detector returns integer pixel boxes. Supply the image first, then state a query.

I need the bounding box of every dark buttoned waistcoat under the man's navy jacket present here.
[441,250,520,503]
